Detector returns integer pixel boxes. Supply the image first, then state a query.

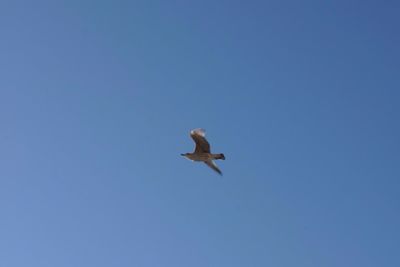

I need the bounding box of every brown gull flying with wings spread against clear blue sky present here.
[181,128,225,175]
